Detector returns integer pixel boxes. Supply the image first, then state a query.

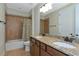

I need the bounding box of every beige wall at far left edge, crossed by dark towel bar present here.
[0,3,5,56]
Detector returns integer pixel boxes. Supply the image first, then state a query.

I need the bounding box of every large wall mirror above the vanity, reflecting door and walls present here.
[40,3,79,36]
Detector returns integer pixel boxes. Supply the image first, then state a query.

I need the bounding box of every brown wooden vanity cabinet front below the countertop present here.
[30,38,66,56]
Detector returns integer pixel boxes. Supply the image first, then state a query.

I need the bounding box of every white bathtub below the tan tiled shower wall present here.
[6,39,24,51]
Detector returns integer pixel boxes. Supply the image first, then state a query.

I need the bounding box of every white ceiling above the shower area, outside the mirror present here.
[6,3,37,13]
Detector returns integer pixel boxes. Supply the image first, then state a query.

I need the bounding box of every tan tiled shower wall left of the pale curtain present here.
[6,15,24,41]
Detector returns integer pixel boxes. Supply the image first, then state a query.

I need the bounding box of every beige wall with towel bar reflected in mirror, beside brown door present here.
[49,11,58,35]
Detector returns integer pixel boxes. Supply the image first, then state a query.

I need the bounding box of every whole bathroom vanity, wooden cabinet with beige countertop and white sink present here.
[30,36,79,56]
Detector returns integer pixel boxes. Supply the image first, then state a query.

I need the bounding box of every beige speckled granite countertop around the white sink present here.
[31,36,79,56]
